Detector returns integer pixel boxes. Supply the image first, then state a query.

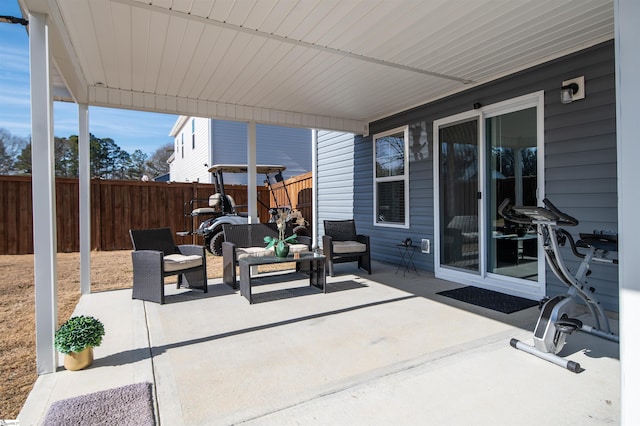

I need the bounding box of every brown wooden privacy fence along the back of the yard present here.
[0,176,311,255]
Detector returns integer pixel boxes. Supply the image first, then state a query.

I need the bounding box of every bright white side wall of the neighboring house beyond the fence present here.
[170,117,211,183]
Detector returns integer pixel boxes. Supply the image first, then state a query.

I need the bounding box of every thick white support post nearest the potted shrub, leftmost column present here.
[29,13,58,374]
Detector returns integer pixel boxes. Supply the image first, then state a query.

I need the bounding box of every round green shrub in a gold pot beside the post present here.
[54,315,104,370]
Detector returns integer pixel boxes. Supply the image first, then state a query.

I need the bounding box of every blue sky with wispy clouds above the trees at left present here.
[0,0,178,155]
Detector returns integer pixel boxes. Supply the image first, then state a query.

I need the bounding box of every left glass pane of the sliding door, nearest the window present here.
[438,118,480,272]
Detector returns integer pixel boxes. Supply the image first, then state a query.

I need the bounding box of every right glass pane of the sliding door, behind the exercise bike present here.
[485,108,538,281]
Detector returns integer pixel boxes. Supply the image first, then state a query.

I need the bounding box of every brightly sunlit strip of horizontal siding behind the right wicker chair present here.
[318,130,360,236]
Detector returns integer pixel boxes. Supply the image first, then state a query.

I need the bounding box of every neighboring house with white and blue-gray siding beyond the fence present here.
[169,116,311,185]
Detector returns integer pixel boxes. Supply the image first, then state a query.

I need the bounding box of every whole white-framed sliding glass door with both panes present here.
[434,93,544,298]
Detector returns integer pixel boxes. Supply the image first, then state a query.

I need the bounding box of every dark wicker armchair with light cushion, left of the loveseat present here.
[129,228,207,304]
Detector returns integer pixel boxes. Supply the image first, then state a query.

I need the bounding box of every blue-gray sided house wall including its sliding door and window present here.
[318,40,618,311]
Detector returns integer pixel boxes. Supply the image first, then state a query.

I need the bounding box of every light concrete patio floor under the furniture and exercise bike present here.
[19,263,620,426]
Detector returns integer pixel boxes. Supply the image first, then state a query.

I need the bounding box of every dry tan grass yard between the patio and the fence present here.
[0,250,230,419]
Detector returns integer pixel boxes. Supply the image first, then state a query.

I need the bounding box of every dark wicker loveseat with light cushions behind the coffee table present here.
[222,223,311,289]
